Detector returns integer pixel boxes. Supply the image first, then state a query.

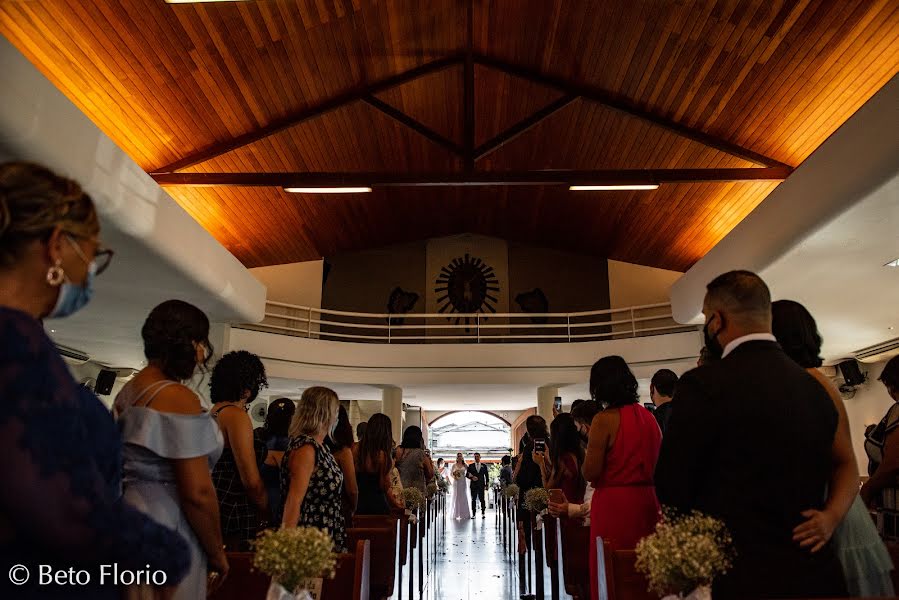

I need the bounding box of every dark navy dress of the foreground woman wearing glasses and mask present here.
[0,307,190,600]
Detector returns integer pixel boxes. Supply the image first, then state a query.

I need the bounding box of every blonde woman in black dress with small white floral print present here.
[281,387,346,552]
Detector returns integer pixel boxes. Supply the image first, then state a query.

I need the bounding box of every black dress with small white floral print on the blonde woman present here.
[281,435,346,552]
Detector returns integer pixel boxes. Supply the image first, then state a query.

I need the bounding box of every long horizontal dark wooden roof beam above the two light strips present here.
[153,167,791,187]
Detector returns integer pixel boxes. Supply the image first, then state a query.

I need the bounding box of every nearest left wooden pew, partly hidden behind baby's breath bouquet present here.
[209,540,371,600]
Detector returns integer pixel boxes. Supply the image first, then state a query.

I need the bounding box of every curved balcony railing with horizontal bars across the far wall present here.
[240,302,697,344]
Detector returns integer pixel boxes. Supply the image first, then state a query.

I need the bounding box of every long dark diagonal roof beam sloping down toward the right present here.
[474,54,791,168]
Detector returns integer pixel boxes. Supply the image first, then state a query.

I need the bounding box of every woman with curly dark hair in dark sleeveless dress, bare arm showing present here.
[209,350,270,550]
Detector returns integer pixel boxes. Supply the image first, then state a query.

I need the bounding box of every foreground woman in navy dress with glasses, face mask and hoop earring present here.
[0,162,190,599]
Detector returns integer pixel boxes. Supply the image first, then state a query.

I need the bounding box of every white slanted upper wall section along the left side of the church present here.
[0,38,266,366]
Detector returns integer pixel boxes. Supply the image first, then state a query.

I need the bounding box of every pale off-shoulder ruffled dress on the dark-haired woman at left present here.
[116,381,223,600]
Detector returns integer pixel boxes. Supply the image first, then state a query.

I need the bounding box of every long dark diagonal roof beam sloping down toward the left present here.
[154,55,463,173]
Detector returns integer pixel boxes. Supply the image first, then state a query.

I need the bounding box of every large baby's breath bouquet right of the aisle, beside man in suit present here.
[637,509,734,598]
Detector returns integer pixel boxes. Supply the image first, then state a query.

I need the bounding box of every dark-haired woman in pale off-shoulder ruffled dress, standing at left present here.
[114,300,228,600]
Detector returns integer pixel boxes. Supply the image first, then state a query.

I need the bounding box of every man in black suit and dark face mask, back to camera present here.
[655,271,846,599]
